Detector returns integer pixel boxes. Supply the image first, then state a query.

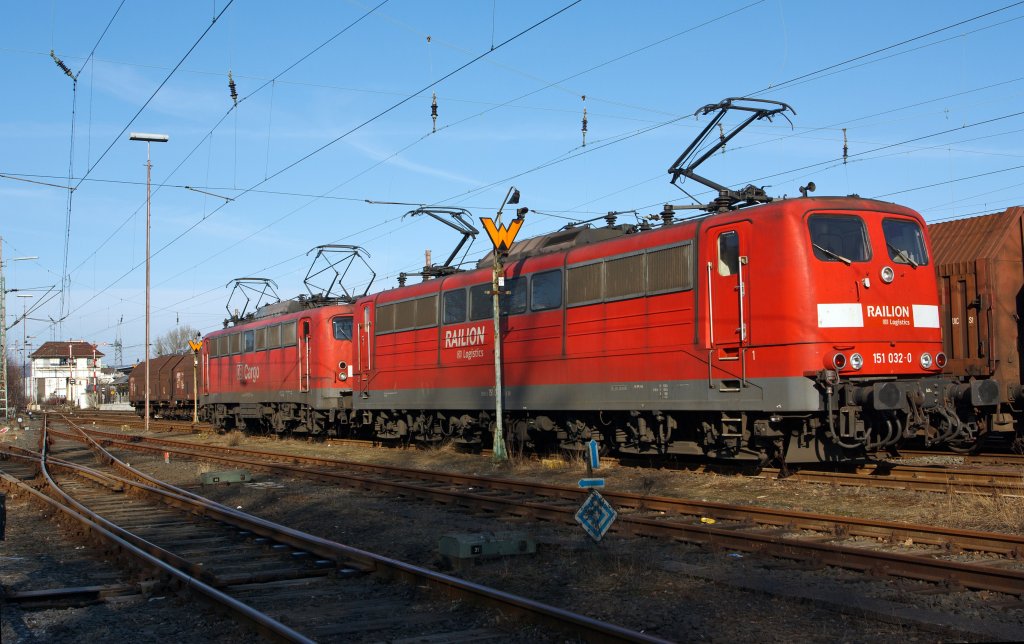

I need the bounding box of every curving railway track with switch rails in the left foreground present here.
[3,423,660,642]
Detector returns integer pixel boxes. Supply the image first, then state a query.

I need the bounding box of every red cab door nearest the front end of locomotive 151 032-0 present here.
[703,221,751,388]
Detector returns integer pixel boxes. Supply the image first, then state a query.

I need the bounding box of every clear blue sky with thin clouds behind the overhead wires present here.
[0,0,1024,362]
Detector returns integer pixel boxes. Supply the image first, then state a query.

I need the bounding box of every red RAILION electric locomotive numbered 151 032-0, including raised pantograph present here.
[353,99,998,462]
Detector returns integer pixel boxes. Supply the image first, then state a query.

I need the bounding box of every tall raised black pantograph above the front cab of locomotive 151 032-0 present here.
[665,97,797,213]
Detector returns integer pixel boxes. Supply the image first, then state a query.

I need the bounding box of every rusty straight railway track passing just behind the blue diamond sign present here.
[34,417,1024,595]
